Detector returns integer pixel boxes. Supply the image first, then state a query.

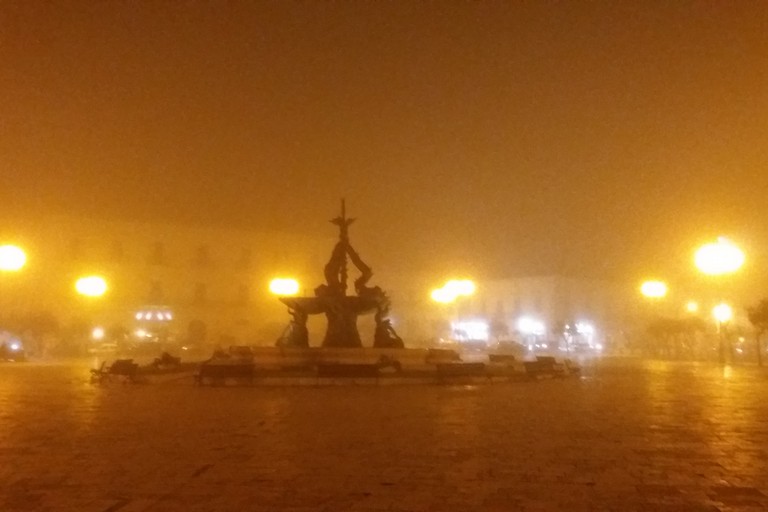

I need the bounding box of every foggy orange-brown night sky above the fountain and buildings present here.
[0,0,768,286]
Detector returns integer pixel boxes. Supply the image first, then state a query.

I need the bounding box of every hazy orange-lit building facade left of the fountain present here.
[2,212,331,344]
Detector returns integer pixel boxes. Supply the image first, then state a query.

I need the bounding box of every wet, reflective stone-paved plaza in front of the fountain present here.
[0,359,768,512]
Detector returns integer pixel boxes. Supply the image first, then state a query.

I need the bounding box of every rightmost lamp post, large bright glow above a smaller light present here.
[694,237,745,364]
